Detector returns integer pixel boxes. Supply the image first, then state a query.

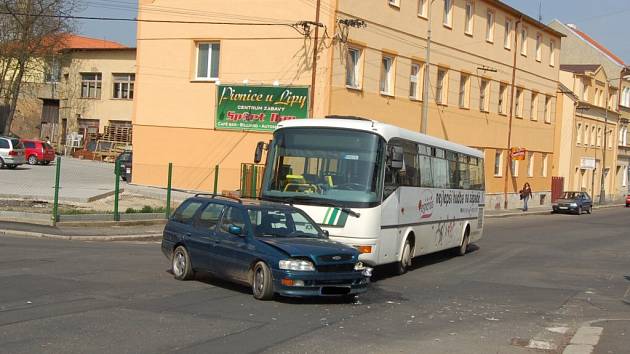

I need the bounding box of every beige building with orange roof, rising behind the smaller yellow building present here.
[549,20,630,199]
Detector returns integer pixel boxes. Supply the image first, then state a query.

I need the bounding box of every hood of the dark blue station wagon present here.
[259,237,358,260]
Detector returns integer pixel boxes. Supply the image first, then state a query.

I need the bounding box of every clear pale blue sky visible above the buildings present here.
[78,0,630,63]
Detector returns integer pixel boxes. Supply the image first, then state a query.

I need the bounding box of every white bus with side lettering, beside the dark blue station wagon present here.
[256,117,484,274]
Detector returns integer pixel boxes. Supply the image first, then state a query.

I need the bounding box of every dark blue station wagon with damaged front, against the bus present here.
[162,195,372,300]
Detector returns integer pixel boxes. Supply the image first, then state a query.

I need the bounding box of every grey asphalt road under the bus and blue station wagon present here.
[0,208,630,353]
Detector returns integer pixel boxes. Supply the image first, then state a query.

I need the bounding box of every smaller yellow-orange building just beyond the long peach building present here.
[554,64,620,200]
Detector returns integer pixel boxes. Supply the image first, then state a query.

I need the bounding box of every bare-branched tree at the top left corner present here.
[0,0,77,134]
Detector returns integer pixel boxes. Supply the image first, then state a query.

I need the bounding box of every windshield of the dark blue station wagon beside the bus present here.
[247,208,325,238]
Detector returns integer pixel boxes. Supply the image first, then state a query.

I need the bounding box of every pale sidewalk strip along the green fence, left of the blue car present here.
[0,221,164,241]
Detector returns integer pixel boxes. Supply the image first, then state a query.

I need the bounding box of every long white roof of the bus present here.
[277,118,484,158]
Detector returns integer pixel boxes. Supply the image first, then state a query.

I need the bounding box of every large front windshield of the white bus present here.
[262,128,385,208]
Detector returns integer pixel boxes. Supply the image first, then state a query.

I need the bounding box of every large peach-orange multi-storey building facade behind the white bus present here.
[134,0,562,208]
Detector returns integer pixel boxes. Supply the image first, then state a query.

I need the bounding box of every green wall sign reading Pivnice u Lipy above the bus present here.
[214,85,309,131]
